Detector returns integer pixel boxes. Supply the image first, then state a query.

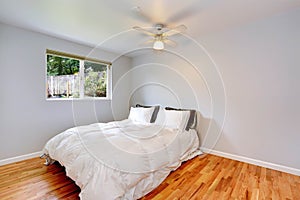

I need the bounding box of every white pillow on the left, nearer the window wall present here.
[128,107,154,123]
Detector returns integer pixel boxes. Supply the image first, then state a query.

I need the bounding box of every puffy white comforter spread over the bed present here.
[43,120,201,200]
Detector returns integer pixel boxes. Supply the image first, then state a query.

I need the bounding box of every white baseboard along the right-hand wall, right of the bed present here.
[200,147,300,176]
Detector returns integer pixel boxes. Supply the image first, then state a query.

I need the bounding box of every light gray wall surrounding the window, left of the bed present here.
[0,24,131,160]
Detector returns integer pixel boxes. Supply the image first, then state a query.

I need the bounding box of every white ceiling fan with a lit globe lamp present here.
[133,23,187,50]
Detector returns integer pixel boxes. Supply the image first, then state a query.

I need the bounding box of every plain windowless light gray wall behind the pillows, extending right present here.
[131,9,300,169]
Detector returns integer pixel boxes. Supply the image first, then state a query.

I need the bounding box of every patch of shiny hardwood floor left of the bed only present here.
[0,158,80,200]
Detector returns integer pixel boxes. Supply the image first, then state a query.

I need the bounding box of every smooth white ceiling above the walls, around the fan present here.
[0,0,300,52]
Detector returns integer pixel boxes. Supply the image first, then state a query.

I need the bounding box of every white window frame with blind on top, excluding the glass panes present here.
[45,49,112,101]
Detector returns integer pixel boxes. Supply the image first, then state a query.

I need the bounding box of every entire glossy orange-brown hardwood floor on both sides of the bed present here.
[0,155,300,200]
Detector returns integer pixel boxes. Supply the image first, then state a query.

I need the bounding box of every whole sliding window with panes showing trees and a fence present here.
[46,50,111,99]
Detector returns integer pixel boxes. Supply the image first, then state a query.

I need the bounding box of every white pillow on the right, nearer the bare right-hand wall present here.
[164,110,190,131]
